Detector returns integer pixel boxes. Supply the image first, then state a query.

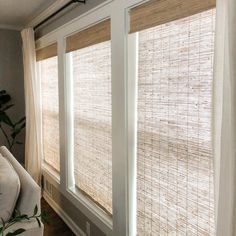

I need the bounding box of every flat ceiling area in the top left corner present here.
[0,0,58,30]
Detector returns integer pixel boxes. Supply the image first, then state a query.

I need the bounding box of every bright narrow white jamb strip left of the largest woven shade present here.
[127,33,138,236]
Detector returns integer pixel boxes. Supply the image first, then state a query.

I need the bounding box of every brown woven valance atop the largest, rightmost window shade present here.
[130,0,216,33]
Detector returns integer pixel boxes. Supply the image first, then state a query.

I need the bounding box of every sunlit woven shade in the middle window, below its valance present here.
[72,41,112,213]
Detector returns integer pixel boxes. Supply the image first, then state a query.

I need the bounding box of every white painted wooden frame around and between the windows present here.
[36,0,152,236]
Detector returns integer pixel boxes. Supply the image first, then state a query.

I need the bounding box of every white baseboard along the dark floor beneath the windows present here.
[43,191,86,236]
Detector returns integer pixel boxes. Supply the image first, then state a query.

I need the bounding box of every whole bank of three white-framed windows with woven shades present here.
[36,0,218,236]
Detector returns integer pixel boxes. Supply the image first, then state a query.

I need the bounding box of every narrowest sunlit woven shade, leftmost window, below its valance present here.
[38,56,60,172]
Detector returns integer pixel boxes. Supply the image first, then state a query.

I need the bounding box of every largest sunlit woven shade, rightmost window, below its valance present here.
[137,8,215,236]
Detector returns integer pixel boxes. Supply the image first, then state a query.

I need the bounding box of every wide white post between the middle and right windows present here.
[111,0,129,236]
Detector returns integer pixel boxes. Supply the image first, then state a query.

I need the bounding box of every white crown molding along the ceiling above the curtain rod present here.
[26,0,70,27]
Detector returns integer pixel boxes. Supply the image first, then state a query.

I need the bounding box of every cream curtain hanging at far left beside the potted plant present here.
[21,28,42,184]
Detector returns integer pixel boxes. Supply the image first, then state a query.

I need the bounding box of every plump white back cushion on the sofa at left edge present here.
[0,154,20,222]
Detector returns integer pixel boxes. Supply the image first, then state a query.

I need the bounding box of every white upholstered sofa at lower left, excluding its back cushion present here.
[0,146,44,236]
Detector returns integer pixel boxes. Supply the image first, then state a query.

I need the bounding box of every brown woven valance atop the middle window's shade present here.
[66,19,111,52]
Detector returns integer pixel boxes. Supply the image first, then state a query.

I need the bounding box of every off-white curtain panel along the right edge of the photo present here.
[213,0,236,236]
